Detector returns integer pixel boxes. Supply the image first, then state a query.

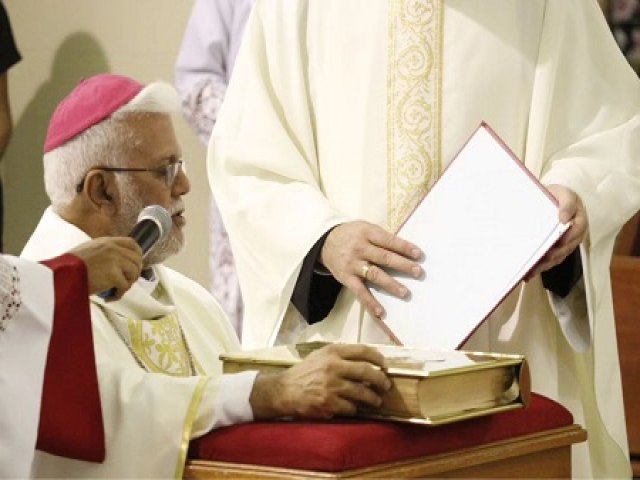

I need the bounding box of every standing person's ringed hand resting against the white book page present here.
[320,221,424,317]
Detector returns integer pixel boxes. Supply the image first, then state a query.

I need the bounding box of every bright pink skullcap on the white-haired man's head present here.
[44,73,144,153]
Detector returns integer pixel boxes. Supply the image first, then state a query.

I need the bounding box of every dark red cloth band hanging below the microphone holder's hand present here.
[36,254,105,462]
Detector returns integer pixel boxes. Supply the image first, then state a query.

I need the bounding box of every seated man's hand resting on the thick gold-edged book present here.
[250,344,391,419]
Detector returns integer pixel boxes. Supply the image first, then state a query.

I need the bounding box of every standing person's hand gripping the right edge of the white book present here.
[527,185,589,279]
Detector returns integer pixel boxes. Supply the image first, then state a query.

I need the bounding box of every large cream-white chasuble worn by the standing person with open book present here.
[208,0,640,476]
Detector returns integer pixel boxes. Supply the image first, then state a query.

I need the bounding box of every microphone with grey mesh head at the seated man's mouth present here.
[98,205,173,300]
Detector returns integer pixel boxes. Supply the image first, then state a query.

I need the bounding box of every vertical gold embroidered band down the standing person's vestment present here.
[387,0,444,232]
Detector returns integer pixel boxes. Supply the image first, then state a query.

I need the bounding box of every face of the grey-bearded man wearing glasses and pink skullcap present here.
[114,114,190,266]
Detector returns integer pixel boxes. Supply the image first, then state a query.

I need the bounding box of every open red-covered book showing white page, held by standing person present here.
[371,124,569,349]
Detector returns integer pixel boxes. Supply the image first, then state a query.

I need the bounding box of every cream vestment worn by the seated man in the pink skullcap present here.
[22,207,255,478]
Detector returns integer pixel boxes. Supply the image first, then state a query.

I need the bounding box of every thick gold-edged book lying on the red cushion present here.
[220,342,531,425]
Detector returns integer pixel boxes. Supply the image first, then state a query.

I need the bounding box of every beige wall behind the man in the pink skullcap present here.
[3,0,209,286]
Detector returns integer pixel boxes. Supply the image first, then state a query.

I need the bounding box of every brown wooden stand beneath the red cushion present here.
[185,424,587,479]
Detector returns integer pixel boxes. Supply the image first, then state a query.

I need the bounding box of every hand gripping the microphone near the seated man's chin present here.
[69,237,142,300]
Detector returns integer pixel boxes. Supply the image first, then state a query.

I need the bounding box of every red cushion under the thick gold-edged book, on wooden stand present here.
[189,394,573,472]
